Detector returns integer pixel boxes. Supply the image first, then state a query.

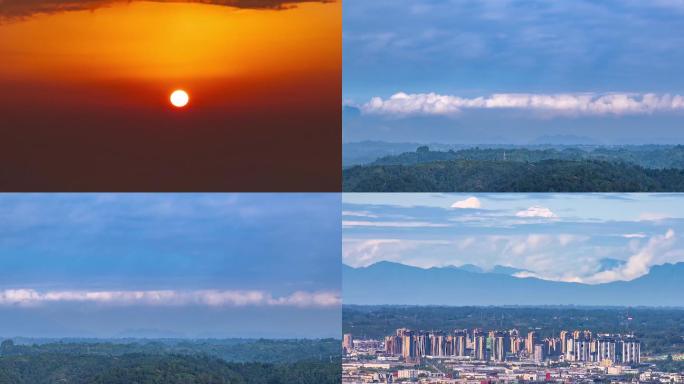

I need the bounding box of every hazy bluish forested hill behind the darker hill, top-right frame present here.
[369,145,684,169]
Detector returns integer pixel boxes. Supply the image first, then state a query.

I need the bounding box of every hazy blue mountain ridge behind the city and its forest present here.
[342,261,684,307]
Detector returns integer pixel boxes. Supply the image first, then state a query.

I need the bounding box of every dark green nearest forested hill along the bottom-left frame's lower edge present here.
[0,353,341,384]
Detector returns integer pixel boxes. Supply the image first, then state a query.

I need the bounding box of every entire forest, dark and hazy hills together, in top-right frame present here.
[343,145,684,192]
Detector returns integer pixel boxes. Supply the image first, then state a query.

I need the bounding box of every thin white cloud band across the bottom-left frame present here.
[0,288,341,307]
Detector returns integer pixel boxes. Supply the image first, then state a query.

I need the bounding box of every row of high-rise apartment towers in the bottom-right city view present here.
[343,328,641,365]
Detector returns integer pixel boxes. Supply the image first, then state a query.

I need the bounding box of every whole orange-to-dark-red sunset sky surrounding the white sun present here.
[0,0,342,191]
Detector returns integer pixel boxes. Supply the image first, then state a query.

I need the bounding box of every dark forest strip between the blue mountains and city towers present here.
[342,306,684,355]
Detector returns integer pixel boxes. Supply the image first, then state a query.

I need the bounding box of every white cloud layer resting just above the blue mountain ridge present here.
[342,229,684,284]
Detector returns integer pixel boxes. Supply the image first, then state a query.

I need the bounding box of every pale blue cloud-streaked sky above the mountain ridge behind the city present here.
[342,193,684,284]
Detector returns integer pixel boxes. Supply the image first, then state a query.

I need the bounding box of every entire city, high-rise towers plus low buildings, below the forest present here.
[342,328,684,384]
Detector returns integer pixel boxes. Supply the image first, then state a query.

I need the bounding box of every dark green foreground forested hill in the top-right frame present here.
[343,159,684,192]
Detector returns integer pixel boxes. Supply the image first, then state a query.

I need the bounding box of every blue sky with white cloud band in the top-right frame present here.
[343,0,684,144]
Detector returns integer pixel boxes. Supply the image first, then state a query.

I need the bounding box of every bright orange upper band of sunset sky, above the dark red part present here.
[0,1,342,82]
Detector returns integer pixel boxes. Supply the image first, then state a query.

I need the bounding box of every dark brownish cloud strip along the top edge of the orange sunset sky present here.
[0,0,335,18]
